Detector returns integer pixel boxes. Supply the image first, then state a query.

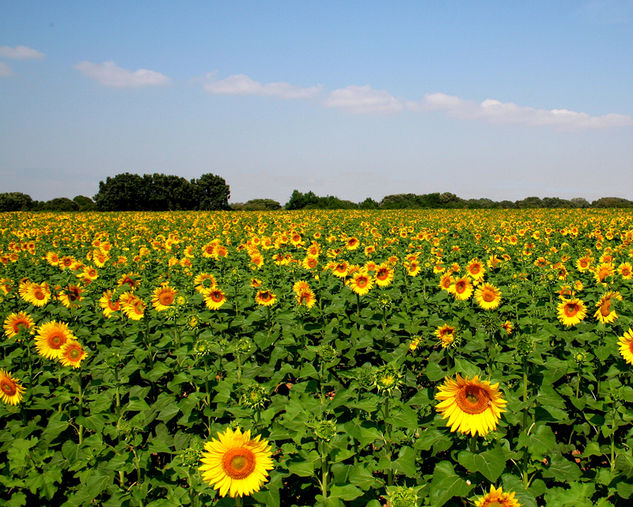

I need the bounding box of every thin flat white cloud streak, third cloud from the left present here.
[204,72,321,99]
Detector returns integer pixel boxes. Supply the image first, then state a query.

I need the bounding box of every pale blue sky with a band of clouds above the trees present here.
[0,0,633,204]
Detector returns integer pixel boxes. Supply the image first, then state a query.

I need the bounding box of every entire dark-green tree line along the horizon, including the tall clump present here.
[0,172,633,211]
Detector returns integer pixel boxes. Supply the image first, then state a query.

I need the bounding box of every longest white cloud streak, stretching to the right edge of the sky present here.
[407,93,633,129]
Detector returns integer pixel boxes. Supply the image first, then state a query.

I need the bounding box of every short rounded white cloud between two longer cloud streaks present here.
[323,85,403,114]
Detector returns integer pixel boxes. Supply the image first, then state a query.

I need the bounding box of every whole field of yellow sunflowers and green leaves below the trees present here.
[0,210,633,507]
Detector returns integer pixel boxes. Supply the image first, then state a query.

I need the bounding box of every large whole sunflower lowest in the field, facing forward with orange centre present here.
[198,428,273,498]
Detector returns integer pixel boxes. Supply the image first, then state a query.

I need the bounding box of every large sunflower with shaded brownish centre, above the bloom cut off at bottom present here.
[435,374,507,437]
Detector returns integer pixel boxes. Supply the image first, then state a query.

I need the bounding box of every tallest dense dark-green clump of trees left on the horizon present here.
[94,173,231,211]
